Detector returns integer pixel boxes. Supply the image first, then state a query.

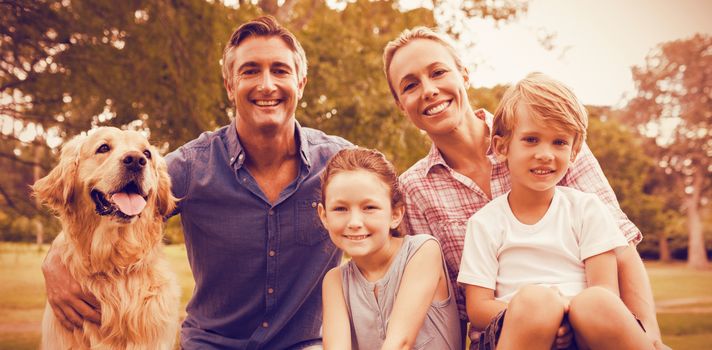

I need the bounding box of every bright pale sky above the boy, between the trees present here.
[458,0,712,107]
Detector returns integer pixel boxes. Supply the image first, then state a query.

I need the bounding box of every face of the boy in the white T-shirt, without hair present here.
[493,106,574,195]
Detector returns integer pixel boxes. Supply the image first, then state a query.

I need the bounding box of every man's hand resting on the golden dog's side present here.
[42,245,101,331]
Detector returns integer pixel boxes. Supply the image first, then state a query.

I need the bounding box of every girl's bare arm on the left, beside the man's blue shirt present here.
[322,267,351,350]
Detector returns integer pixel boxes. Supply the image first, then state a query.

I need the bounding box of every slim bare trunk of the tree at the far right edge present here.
[686,168,709,269]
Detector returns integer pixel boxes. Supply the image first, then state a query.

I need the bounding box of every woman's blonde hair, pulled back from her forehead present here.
[383,26,465,101]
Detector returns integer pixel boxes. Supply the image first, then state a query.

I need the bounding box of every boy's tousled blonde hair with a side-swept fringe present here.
[492,73,588,157]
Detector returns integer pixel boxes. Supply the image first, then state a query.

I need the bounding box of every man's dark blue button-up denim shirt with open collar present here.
[166,122,351,349]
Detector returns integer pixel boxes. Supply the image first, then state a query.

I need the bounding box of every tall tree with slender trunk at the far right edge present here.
[628,34,712,268]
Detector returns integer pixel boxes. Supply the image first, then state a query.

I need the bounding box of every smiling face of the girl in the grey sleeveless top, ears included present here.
[319,170,404,258]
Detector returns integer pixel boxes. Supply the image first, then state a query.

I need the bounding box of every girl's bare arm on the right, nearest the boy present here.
[381,240,442,350]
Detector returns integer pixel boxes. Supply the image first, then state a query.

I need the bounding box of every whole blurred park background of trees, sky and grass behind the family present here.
[0,0,712,349]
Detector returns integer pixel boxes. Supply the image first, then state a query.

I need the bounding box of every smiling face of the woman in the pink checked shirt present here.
[388,39,471,137]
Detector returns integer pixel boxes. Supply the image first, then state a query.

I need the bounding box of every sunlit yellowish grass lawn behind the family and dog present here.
[0,243,712,349]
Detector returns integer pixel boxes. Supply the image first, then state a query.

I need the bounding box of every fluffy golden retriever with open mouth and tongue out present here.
[33,127,179,349]
